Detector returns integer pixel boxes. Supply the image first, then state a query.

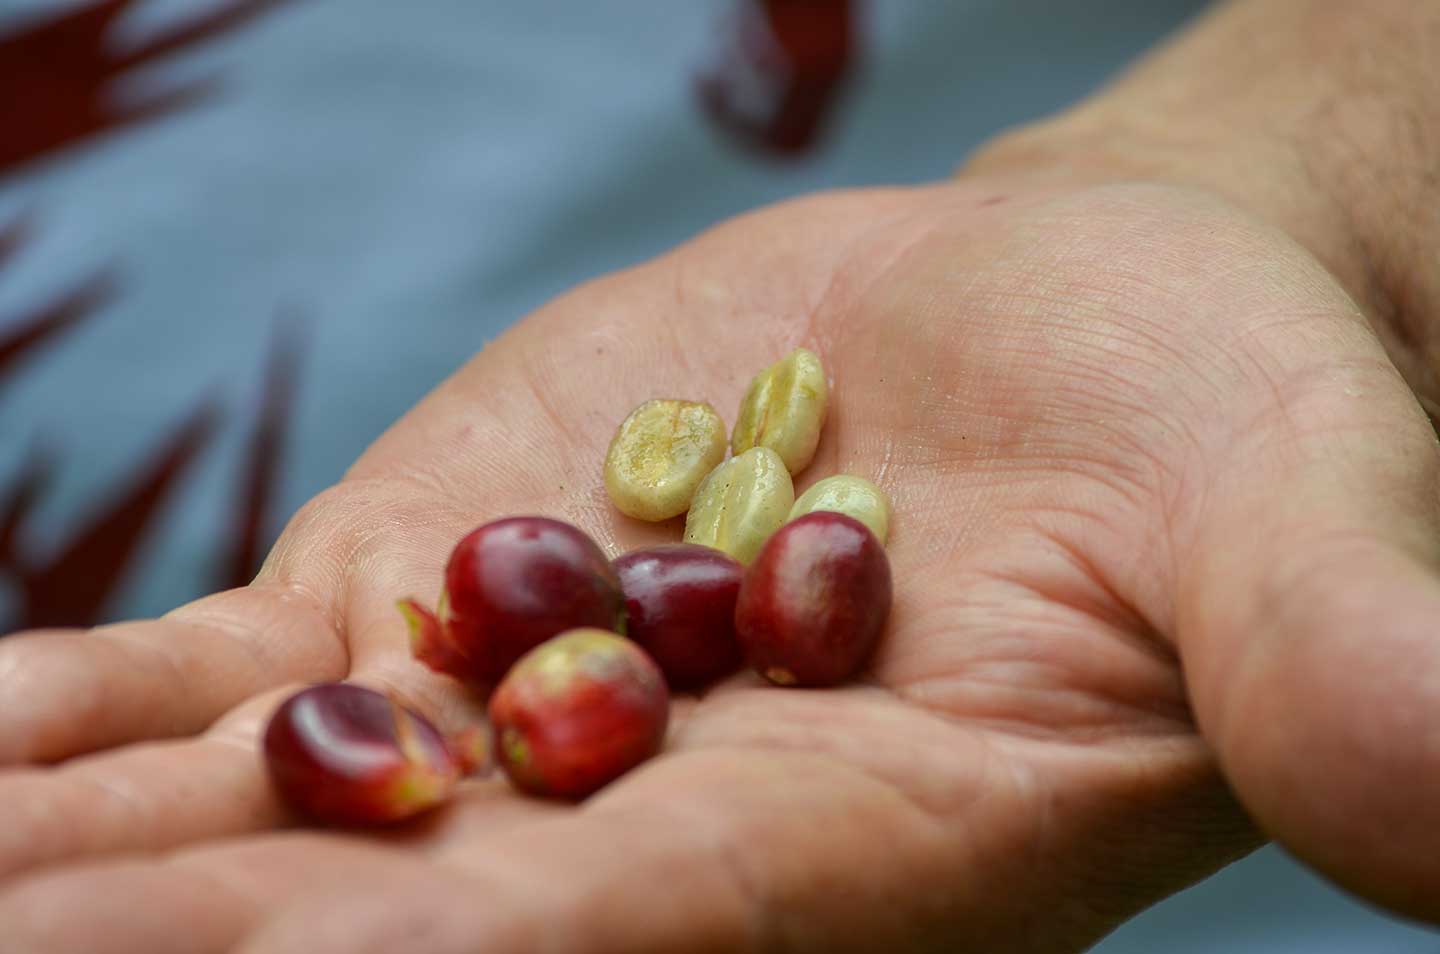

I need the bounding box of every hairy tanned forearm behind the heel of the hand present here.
[968,0,1440,414]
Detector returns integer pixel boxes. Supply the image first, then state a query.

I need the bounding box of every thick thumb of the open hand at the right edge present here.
[1176,354,1440,921]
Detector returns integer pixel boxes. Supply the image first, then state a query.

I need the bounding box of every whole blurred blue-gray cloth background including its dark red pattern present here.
[0,0,1440,954]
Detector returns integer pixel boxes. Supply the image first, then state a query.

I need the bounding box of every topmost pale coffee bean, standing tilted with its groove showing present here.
[730,347,829,474]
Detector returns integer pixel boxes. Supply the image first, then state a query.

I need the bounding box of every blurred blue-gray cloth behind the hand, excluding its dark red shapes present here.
[0,0,1440,954]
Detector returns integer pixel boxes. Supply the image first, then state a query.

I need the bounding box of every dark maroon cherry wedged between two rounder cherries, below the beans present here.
[615,543,744,690]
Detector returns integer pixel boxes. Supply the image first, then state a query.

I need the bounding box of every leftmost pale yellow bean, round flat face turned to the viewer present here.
[605,399,726,520]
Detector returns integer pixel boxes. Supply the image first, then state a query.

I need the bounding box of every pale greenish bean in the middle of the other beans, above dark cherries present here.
[685,447,795,563]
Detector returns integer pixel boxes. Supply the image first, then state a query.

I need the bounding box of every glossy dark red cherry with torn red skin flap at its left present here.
[400,516,625,689]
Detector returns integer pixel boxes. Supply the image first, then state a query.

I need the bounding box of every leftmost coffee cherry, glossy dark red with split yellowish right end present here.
[264,683,484,826]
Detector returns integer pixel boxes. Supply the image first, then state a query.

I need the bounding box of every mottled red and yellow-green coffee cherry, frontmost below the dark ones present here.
[490,628,670,800]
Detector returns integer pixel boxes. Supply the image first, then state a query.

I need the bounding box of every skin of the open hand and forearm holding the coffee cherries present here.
[0,0,1440,954]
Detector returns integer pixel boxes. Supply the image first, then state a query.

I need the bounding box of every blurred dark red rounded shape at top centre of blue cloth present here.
[698,0,857,156]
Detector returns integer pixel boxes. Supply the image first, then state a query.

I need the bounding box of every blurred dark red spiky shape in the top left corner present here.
[0,0,289,174]
